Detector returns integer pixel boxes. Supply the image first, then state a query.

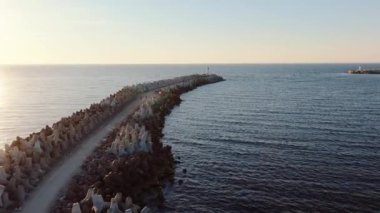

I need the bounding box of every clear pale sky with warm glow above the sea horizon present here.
[0,0,380,64]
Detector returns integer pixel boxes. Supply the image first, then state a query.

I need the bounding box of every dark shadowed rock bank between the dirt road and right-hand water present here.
[51,76,223,213]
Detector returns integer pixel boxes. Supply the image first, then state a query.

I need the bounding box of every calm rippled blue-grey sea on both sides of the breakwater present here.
[0,64,380,212]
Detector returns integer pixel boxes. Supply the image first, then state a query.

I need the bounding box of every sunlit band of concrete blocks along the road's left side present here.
[0,75,224,211]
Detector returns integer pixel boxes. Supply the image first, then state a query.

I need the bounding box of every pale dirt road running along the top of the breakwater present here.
[21,84,176,213]
